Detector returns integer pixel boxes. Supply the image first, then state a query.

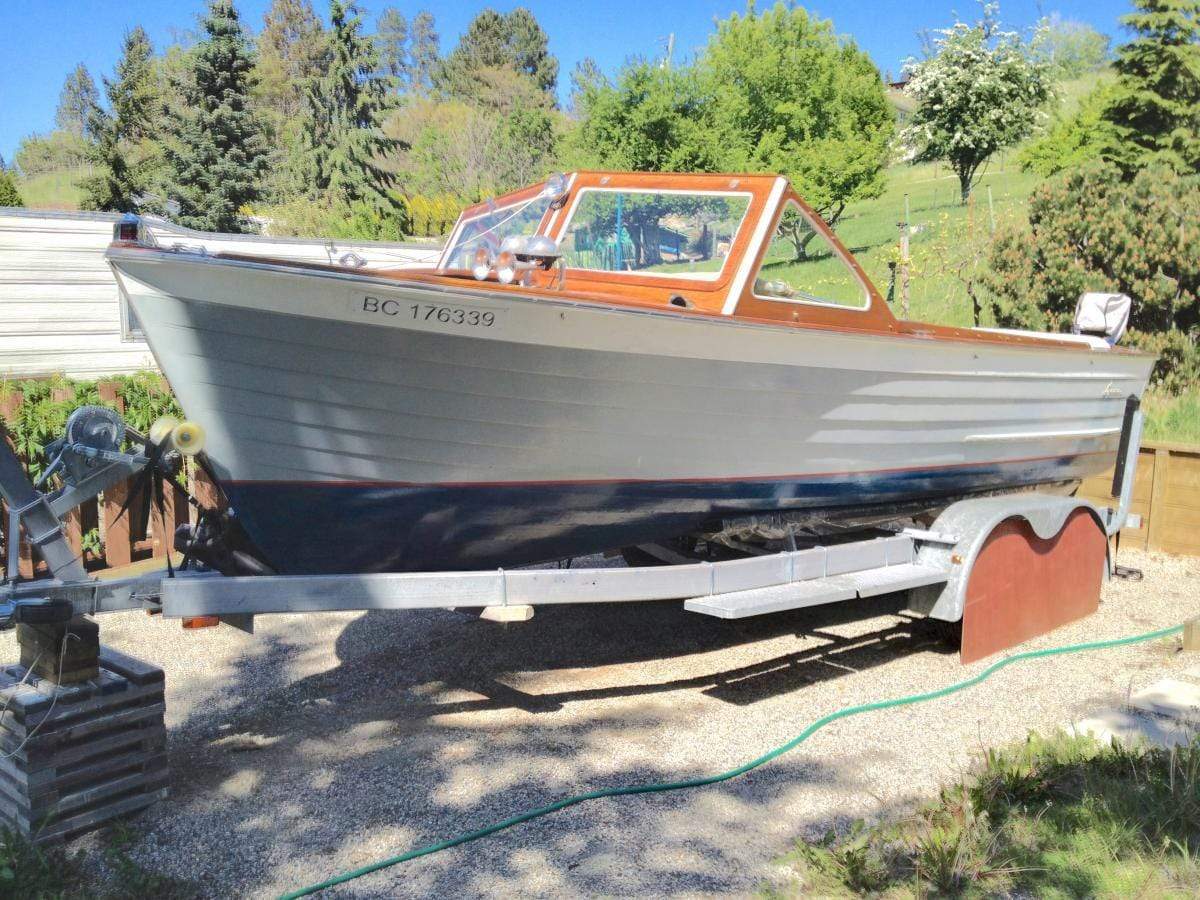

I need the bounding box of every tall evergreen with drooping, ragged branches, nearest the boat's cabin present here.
[296,0,400,209]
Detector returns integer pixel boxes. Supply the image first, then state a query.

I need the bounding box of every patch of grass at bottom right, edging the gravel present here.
[766,734,1200,898]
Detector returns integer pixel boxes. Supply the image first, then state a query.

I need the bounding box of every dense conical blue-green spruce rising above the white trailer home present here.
[167,0,266,232]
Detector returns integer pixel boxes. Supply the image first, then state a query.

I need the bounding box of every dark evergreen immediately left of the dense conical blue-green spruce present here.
[79,26,162,212]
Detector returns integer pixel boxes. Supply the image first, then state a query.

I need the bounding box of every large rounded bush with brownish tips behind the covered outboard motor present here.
[984,163,1200,332]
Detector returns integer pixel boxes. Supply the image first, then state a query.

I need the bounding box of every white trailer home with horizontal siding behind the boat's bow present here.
[0,206,440,380]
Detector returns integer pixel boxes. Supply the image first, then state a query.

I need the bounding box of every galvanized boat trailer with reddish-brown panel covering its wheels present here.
[0,397,1142,662]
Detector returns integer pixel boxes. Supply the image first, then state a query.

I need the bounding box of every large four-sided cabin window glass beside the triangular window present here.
[559,188,750,280]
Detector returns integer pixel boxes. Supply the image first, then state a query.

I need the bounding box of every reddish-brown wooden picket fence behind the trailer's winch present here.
[0,382,196,578]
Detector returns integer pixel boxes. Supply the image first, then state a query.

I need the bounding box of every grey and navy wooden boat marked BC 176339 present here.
[107,172,1153,574]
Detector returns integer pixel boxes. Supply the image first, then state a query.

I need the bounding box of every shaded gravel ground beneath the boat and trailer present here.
[0,552,1200,896]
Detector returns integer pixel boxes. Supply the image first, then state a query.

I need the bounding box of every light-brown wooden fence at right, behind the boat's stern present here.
[1079,440,1200,556]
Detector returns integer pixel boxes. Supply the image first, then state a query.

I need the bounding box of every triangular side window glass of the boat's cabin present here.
[754,202,870,308]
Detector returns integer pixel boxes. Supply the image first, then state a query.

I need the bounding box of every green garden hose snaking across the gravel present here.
[281,625,1183,900]
